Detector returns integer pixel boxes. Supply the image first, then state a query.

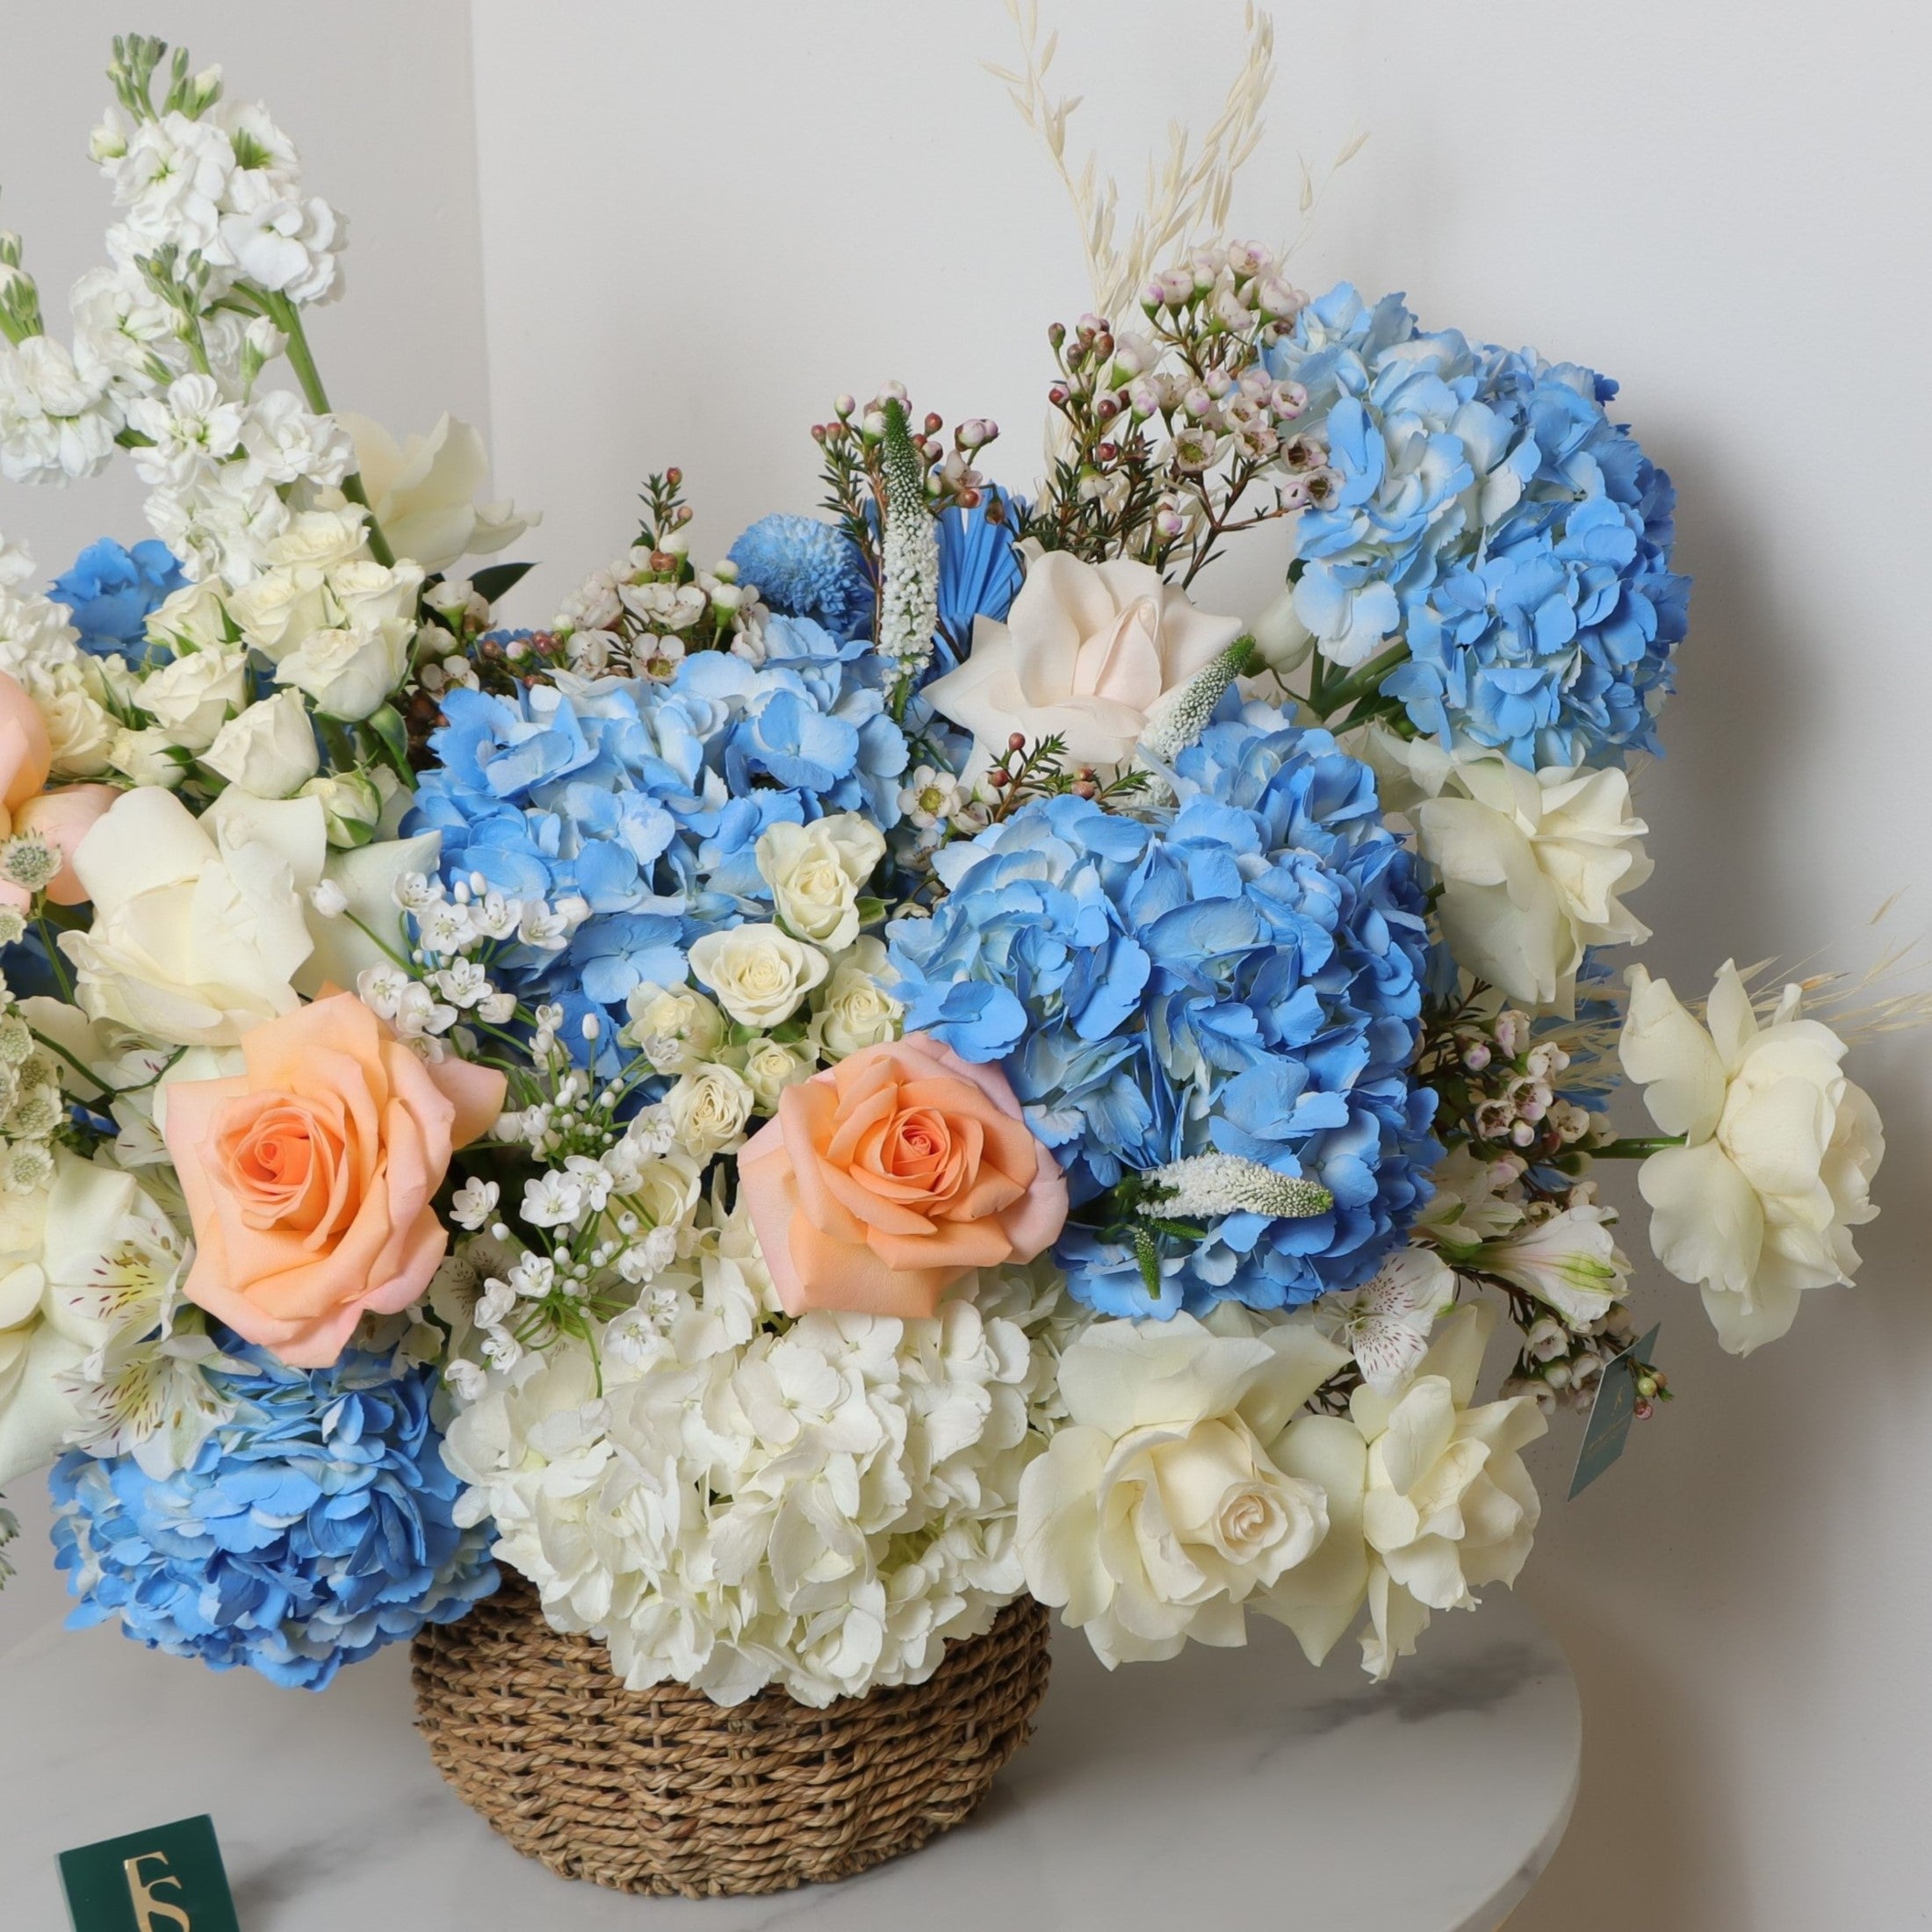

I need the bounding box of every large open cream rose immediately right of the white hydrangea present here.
[1018,1314,1349,1669]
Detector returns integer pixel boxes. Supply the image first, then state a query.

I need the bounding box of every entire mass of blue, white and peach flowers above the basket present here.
[0,23,1903,1800]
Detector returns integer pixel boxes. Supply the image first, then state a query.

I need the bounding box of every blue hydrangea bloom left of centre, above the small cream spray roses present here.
[407,616,906,1032]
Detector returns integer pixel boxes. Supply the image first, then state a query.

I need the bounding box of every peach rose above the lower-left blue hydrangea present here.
[164,993,504,1368]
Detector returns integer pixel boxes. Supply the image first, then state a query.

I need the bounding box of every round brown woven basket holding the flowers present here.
[400,1576,1047,1897]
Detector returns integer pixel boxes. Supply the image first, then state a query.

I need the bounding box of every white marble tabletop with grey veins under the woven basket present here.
[0,1484,1581,1932]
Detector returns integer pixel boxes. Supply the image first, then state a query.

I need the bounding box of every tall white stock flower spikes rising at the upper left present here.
[0,40,354,583]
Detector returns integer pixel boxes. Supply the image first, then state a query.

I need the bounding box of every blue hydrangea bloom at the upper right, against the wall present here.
[1269,284,1690,767]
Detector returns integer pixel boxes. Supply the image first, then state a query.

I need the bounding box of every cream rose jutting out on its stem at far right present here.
[1623,960,1885,1354]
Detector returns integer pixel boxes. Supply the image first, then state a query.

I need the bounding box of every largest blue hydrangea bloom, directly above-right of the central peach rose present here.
[890,697,1439,1316]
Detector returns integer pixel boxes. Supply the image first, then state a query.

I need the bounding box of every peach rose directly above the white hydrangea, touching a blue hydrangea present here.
[738,1034,1066,1316]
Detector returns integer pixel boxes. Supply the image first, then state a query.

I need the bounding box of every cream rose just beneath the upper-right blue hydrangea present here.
[1410,747,1652,1013]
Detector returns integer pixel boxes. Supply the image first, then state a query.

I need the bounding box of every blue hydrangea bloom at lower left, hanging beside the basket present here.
[50,1337,496,1690]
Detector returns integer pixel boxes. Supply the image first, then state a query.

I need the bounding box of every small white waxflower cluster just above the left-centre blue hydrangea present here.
[548,530,771,680]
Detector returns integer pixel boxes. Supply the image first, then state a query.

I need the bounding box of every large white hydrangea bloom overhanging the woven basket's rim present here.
[444,1204,1085,1708]
